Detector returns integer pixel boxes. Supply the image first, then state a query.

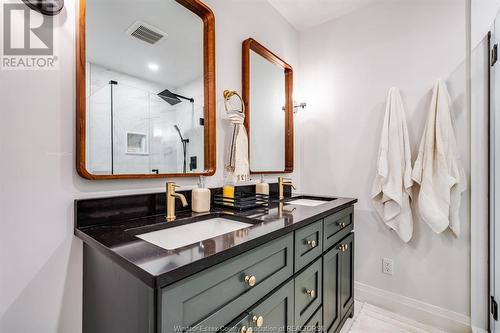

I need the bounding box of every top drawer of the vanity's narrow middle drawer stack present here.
[295,220,323,272]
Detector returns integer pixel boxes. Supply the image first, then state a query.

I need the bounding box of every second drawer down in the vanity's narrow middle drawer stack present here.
[295,258,323,327]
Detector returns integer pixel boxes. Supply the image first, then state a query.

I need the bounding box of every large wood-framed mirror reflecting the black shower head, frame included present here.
[76,0,216,179]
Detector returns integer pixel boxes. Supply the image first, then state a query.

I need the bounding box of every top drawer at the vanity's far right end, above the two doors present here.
[323,206,354,250]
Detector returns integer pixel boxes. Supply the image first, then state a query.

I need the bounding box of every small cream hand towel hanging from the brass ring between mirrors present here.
[224,90,250,181]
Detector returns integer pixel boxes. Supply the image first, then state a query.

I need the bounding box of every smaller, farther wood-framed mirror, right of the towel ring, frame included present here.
[243,38,293,174]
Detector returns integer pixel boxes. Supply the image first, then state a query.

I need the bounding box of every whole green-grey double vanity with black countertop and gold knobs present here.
[75,189,356,333]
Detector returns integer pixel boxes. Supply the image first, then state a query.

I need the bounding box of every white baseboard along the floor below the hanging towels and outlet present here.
[354,282,470,333]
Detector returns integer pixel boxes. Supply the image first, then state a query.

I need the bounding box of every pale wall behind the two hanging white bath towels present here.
[300,0,470,322]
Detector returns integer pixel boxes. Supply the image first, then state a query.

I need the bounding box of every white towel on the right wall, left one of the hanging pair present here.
[372,88,413,243]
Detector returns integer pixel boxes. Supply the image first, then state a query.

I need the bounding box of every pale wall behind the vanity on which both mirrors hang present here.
[0,0,298,333]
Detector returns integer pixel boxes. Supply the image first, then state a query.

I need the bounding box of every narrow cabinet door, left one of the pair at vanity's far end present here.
[323,243,342,333]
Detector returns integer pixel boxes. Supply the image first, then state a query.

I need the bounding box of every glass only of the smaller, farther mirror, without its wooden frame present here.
[249,50,286,172]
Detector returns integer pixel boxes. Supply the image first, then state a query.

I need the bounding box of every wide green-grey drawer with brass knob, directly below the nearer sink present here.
[159,234,293,333]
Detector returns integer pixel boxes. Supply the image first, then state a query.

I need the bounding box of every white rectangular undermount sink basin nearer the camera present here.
[136,217,252,250]
